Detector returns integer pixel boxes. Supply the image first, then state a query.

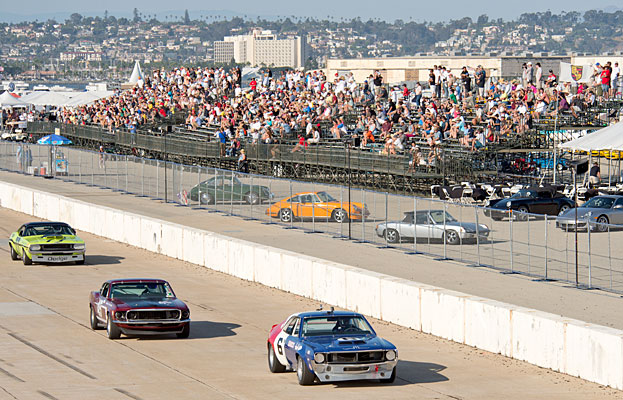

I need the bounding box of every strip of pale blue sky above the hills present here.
[0,0,623,22]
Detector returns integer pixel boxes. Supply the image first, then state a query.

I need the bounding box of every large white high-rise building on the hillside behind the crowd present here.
[214,29,307,68]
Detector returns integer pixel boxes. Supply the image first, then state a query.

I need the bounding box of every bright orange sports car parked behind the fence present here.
[266,192,370,222]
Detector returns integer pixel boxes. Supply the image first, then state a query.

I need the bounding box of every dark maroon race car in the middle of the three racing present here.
[89,279,190,339]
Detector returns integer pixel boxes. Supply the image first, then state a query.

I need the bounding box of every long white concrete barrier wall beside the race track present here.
[0,182,623,389]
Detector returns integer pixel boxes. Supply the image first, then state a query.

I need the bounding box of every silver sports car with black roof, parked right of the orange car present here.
[376,210,489,244]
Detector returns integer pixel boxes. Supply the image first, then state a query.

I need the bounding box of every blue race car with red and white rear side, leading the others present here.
[267,309,398,385]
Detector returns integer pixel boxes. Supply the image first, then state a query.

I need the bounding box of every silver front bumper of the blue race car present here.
[312,360,398,382]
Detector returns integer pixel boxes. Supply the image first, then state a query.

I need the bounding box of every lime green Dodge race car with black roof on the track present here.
[9,222,86,265]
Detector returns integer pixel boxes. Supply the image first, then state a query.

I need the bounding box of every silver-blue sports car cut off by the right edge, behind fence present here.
[556,195,623,232]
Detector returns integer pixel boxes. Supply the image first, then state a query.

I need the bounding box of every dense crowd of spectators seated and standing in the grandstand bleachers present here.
[46,63,621,171]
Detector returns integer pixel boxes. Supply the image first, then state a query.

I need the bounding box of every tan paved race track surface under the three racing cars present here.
[0,209,620,400]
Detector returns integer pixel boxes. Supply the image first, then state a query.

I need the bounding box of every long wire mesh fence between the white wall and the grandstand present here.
[0,142,623,293]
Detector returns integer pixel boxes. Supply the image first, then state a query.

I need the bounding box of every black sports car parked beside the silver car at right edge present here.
[484,187,575,221]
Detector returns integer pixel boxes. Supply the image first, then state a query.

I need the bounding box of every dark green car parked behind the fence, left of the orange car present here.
[189,176,274,205]
